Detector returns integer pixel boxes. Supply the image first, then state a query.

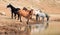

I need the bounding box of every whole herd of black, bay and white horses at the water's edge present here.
[7,4,49,24]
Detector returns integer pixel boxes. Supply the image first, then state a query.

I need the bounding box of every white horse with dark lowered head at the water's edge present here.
[33,10,49,21]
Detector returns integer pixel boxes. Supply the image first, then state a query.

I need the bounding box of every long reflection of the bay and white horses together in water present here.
[17,22,48,35]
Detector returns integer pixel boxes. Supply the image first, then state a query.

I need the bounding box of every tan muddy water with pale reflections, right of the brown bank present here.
[31,21,60,35]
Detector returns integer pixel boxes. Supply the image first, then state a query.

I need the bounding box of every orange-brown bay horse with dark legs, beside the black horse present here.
[18,9,33,24]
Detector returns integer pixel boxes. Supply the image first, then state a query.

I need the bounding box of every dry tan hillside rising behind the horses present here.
[0,0,60,15]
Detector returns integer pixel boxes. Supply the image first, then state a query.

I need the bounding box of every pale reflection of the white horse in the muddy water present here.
[29,22,48,33]
